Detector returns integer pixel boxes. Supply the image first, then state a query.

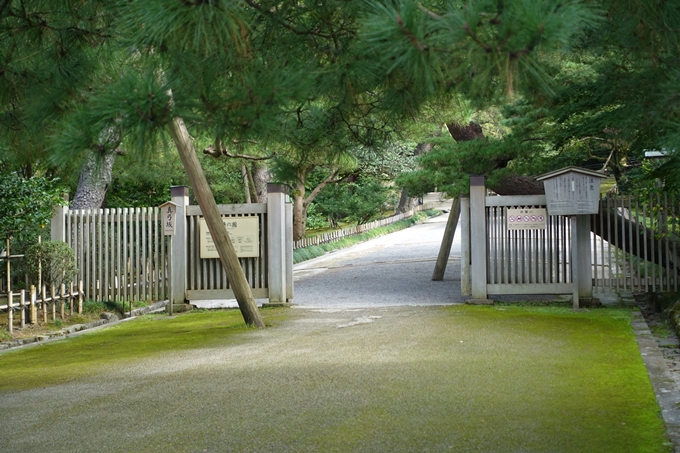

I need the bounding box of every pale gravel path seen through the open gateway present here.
[293,215,466,307]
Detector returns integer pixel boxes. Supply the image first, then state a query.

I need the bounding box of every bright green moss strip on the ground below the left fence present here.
[0,309,290,391]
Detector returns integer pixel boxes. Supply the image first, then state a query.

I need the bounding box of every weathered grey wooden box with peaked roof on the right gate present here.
[536,167,607,215]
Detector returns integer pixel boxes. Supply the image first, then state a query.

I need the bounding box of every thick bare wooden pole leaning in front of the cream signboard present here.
[169,118,264,327]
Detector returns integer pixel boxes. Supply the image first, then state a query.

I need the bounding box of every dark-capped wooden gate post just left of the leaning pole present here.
[169,186,189,305]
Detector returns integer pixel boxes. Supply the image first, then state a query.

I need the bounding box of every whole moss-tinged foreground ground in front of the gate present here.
[0,305,671,453]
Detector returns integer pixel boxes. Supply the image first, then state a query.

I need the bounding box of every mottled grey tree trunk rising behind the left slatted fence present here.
[71,151,116,209]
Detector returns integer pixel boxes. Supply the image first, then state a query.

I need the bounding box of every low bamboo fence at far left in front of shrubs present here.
[0,281,83,333]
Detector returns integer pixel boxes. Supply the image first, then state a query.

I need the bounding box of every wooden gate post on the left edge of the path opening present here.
[265,183,292,306]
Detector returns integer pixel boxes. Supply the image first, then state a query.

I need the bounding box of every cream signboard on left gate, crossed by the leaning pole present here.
[198,216,260,258]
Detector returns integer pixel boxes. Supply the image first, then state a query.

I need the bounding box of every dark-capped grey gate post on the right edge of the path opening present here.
[467,175,493,304]
